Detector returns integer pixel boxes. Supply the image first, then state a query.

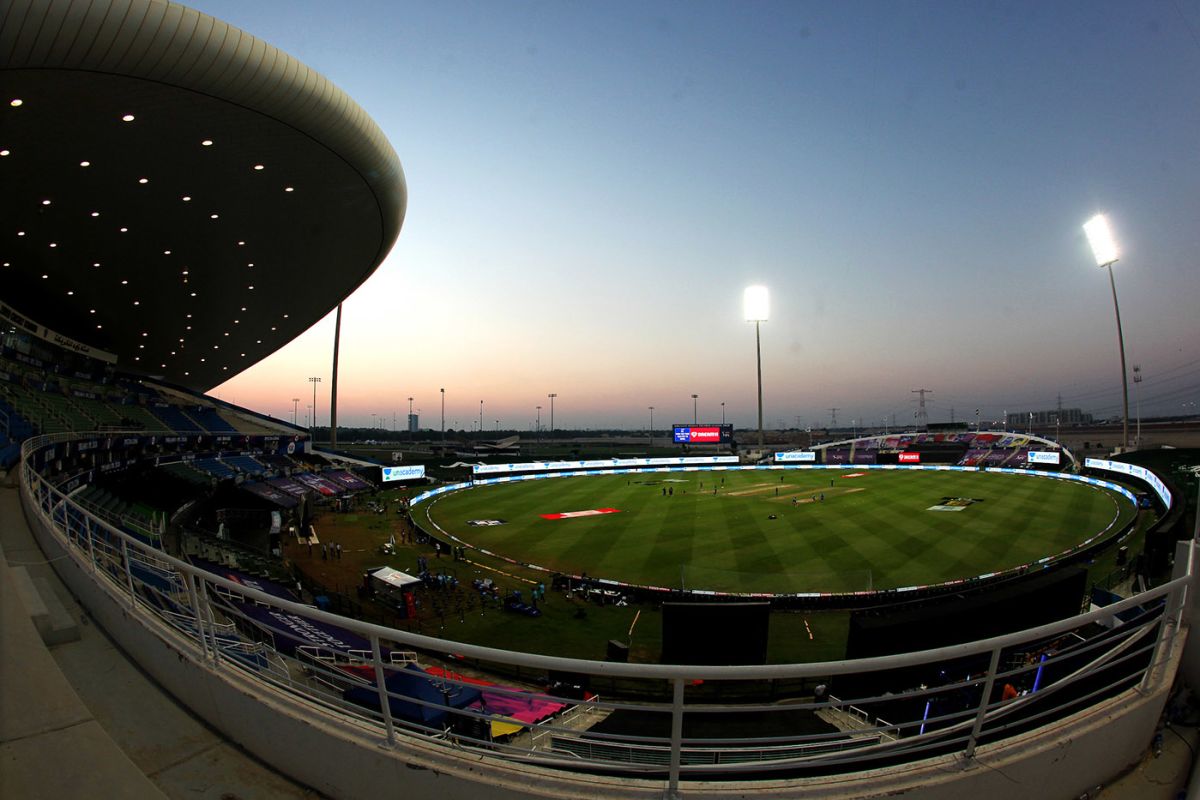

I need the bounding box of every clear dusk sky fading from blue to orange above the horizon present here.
[191,0,1200,431]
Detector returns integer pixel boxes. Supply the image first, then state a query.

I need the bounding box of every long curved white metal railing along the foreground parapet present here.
[22,437,1193,795]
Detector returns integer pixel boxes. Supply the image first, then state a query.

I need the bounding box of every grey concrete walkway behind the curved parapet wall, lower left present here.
[0,487,322,800]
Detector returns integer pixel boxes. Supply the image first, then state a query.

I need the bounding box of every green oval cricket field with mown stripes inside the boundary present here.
[429,470,1134,593]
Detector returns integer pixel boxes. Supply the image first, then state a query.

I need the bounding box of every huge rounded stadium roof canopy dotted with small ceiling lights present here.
[0,0,407,391]
